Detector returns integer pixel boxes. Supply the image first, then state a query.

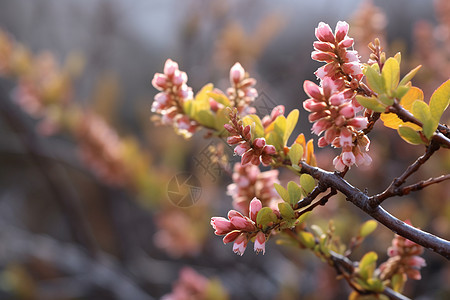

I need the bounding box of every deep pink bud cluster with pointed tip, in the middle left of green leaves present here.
[224,110,277,166]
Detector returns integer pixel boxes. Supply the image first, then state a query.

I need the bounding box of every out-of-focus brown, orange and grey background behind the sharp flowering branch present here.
[0,0,450,299]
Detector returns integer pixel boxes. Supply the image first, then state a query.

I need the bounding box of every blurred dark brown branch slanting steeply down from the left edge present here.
[0,85,98,257]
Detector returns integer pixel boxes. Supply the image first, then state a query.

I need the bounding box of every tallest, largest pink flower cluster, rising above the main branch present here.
[303,22,372,171]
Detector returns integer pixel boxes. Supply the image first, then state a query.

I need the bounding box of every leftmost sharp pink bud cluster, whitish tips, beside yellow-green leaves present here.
[152,59,198,137]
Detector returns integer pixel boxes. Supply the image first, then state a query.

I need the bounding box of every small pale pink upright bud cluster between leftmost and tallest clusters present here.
[227,63,258,115]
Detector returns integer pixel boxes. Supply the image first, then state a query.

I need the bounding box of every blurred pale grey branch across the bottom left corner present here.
[0,221,153,300]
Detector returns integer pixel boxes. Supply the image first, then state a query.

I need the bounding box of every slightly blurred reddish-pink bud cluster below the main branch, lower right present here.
[380,221,426,280]
